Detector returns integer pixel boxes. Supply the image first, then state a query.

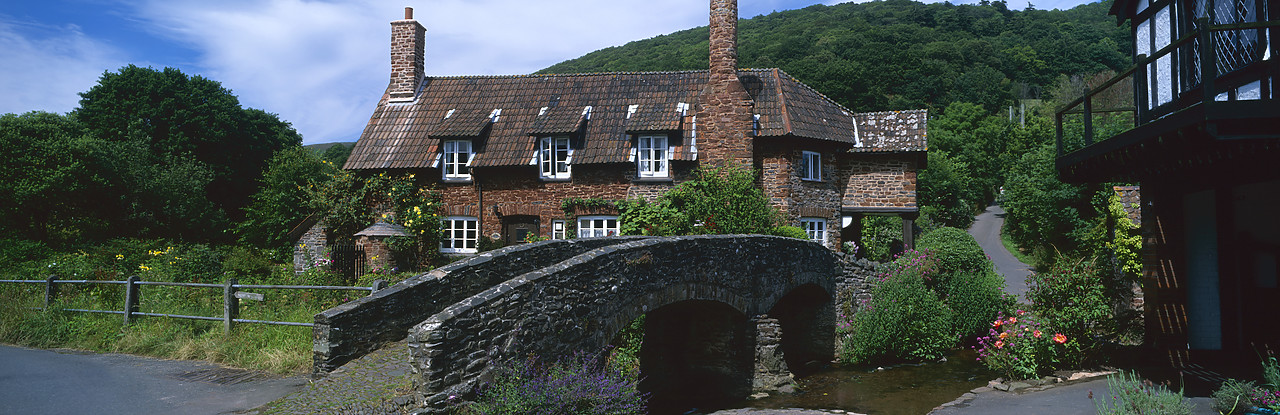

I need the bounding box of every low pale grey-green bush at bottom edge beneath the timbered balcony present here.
[1093,370,1192,415]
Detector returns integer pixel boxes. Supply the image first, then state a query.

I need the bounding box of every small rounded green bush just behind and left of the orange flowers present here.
[938,269,1016,338]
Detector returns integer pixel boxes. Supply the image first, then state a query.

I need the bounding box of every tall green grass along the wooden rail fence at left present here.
[0,239,408,374]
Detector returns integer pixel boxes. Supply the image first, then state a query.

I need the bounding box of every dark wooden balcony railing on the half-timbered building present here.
[1056,19,1280,158]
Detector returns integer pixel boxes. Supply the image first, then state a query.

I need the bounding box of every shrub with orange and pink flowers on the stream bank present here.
[974,310,1069,379]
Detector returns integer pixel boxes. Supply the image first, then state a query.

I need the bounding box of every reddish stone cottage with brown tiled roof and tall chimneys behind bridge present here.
[343,0,928,254]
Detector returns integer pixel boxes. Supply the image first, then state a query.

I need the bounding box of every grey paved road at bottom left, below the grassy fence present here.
[0,346,307,415]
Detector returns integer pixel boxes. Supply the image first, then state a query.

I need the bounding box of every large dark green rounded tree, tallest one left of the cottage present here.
[74,65,301,237]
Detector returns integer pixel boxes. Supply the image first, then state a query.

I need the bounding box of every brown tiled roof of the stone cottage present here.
[344,69,927,169]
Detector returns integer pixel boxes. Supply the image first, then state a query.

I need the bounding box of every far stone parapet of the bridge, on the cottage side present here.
[312,237,643,375]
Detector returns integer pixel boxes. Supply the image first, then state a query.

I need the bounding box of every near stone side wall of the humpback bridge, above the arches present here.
[410,236,841,409]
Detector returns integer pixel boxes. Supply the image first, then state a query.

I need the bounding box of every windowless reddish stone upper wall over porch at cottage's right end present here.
[841,154,919,209]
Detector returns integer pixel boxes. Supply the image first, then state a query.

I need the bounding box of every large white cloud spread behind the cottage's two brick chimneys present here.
[137,0,707,142]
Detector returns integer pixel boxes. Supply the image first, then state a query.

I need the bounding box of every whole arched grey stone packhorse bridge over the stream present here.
[315,236,842,409]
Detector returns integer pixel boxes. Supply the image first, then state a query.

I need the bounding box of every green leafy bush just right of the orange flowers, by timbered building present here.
[1027,260,1114,365]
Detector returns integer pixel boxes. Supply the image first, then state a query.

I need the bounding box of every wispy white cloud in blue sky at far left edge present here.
[0,15,124,114]
